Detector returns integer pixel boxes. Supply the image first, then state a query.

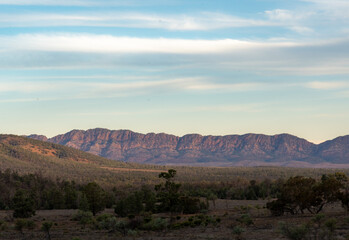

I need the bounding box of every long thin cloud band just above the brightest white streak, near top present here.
[0,12,272,31]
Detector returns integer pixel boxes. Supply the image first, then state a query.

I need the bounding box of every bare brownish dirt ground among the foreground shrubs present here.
[0,200,349,240]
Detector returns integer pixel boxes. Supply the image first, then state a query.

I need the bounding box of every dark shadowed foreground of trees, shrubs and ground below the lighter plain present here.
[0,169,349,240]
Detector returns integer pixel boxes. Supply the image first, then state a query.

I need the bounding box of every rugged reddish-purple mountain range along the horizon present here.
[29,128,349,167]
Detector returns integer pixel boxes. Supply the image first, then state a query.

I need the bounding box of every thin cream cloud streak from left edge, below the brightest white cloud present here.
[0,77,264,97]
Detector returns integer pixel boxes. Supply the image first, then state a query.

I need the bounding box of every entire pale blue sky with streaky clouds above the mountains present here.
[0,0,349,143]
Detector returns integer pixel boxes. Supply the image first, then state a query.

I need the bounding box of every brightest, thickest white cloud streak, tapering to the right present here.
[0,34,303,54]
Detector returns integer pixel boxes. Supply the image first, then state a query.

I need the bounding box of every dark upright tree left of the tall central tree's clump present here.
[83,182,105,216]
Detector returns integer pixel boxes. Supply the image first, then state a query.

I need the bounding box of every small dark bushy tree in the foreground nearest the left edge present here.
[12,189,35,218]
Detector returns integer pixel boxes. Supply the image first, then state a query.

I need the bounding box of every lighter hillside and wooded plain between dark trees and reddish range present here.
[4,135,342,185]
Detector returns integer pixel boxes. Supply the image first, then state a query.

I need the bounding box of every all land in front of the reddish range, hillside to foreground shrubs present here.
[0,135,349,240]
